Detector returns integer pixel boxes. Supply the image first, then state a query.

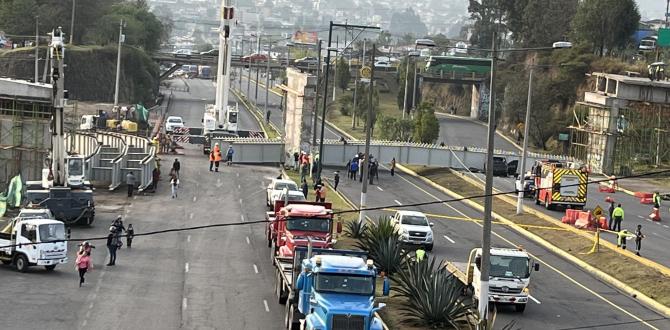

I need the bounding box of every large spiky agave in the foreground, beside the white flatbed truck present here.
[393,257,474,329]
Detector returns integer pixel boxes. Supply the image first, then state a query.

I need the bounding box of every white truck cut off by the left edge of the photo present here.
[0,212,67,272]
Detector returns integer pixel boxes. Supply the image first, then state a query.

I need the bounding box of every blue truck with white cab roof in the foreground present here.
[273,247,388,330]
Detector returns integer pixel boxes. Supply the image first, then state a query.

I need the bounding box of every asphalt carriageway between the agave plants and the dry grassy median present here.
[327,169,670,329]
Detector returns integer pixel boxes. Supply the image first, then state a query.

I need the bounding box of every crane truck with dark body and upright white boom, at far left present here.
[25,27,95,225]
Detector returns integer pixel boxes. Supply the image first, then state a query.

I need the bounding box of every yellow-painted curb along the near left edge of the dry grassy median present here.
[396,164,670,317]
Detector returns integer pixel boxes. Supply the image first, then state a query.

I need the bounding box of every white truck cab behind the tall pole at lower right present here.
[467,247,540,312]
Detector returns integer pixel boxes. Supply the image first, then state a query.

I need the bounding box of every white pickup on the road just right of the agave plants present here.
[391,211,433,251]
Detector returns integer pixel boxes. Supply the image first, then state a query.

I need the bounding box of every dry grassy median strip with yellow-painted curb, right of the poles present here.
[398,165,670,317]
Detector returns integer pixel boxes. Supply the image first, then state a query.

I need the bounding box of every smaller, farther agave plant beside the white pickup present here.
[355,218,407,275]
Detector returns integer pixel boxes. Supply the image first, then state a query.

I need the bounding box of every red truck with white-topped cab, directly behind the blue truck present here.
[265,200,342,259]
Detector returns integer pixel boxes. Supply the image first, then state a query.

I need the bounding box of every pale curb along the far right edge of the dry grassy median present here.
[450,169,670,277]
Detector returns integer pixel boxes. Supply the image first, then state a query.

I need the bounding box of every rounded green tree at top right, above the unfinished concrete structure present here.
[572,0,640,56]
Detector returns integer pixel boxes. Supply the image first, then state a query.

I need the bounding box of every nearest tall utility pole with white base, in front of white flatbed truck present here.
[477,32,498,319]
